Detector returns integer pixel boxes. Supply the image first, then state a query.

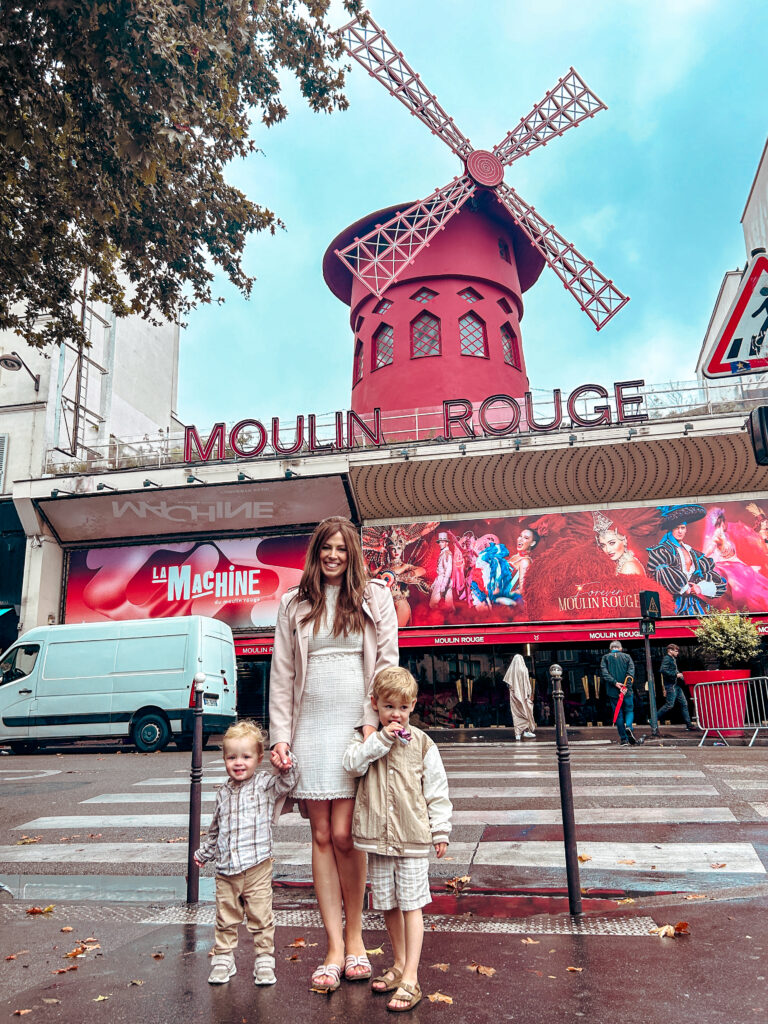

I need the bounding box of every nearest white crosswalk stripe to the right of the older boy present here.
[473,841,766,874]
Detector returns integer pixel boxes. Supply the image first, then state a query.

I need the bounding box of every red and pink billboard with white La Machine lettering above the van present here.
[65,535,309,629]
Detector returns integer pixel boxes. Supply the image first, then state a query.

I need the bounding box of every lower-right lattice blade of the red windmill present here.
[495,182,630,331]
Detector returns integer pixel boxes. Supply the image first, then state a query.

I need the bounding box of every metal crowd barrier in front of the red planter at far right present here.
[693,676,768,746]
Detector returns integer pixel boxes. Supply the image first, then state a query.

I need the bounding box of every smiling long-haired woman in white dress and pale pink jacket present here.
[269,516,399,992]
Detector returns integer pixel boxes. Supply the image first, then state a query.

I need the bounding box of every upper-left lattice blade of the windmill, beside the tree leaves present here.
[338,14,472,160]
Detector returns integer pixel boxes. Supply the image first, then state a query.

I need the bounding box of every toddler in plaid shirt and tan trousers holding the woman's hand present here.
[195,721,299,985]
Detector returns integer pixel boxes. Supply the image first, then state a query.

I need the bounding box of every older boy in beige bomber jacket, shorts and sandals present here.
[344,667,453,1013]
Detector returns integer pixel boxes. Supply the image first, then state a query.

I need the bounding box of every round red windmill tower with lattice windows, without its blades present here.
[323,193,545,438]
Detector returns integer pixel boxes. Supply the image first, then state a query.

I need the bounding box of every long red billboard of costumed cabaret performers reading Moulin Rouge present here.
[362,499,768,628]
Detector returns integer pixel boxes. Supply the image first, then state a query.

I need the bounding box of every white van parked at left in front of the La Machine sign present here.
[0,615,237,754]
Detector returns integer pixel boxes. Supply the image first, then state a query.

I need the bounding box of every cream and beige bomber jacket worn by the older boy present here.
[342,725,453,857]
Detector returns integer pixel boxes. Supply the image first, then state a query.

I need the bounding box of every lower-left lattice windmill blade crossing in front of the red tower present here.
[336,175,476,296]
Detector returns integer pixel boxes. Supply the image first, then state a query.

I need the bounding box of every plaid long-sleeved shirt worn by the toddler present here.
[196,758,299,874]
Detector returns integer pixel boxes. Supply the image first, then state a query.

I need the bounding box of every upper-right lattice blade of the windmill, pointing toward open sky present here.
[494,68,608,165]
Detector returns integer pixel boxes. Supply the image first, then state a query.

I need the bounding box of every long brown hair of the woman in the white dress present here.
[297,516,368,637]
